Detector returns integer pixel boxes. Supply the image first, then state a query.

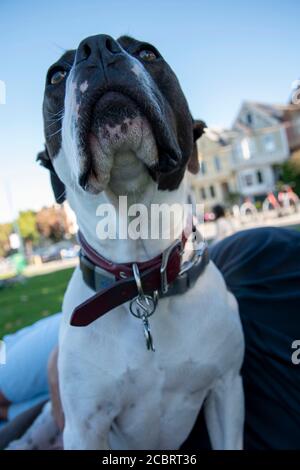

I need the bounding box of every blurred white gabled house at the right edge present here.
[232,102,300,198]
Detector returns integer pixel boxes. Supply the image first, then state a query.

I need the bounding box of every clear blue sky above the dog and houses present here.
[0,0,300,222]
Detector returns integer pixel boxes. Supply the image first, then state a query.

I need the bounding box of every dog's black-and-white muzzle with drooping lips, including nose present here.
[64,35,181,193]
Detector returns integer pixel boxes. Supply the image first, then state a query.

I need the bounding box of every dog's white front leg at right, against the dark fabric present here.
[204,371,244,450]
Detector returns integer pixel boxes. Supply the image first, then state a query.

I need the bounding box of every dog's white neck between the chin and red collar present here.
[67,172,187,263]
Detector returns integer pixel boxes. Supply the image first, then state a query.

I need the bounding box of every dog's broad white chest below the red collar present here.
[60,265,243,449]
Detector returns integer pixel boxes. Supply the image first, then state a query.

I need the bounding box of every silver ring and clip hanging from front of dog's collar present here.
[130,263,158,351]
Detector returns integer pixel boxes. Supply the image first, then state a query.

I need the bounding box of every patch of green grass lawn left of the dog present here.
[0,268,73,339]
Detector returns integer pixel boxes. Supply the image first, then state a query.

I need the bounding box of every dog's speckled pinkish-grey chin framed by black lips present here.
[79,95,158,195]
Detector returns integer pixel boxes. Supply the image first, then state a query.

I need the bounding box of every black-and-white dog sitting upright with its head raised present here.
[40,35,244,450]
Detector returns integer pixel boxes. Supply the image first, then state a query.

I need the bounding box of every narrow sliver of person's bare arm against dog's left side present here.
[48,348,65,431]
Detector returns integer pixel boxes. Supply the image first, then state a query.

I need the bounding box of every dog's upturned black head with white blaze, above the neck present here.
[39,34,204,200]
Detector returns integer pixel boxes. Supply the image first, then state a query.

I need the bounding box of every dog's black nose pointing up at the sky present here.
[75,34,123,65]
